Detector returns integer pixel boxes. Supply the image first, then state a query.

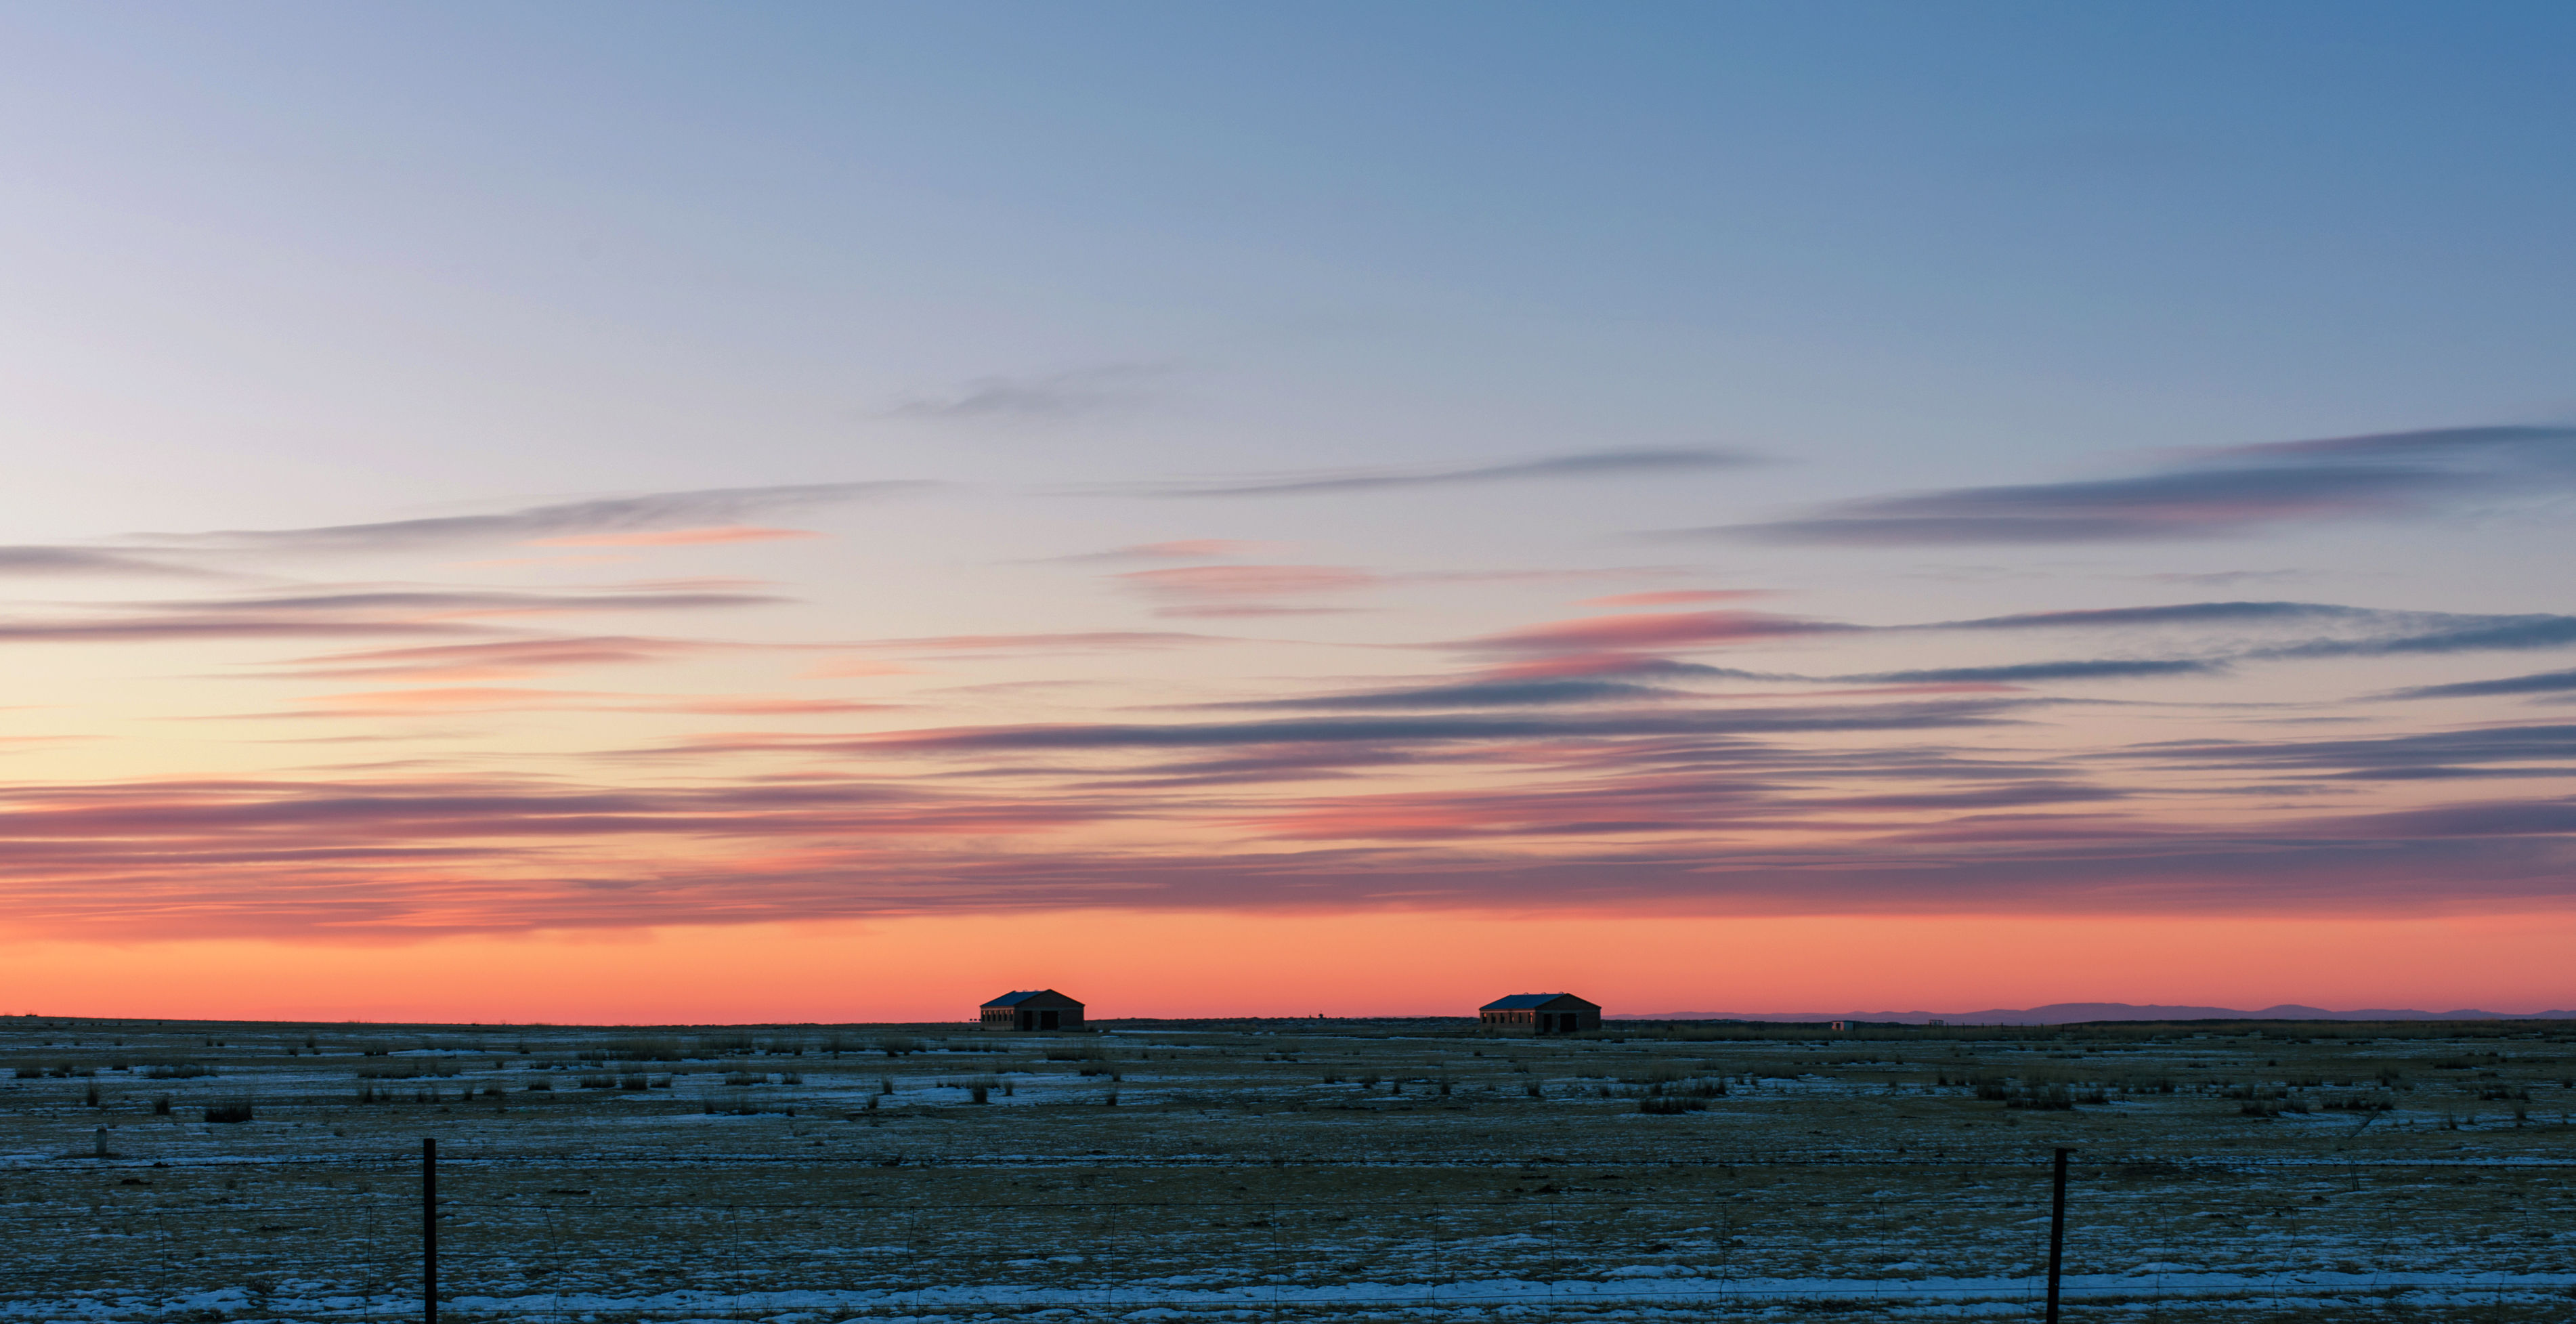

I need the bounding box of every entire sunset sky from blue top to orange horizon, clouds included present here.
[0,0,2576,1023]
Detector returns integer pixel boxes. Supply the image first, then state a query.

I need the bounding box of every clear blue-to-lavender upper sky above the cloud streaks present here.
[0,3,2576,520]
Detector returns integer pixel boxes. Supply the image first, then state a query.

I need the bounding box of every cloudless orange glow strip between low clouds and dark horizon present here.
[0,910,2576,1025]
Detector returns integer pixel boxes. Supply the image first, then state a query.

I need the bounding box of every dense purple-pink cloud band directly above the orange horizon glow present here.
[0,685,2576,937]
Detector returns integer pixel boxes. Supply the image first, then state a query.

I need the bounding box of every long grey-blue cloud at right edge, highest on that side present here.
[1695,427,2576,546]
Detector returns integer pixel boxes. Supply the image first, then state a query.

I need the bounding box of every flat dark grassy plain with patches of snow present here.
[0,1017,2576,1308]
